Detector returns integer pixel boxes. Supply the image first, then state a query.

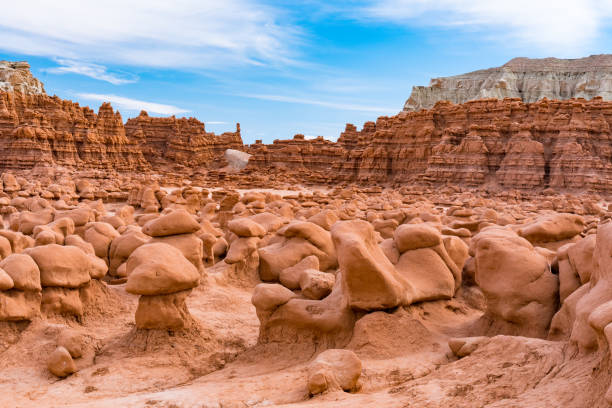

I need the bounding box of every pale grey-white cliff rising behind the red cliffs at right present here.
[404,54,612,111]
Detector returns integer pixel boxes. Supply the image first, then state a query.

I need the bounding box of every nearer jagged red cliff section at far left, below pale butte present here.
[0,92,149,171]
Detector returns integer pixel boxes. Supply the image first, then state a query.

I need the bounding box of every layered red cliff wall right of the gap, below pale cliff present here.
[249,98,612,191]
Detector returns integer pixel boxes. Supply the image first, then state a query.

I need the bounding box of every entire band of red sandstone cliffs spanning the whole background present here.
[0,84,612,191]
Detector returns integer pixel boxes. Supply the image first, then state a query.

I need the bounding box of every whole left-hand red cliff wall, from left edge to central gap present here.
[0,92,243,172]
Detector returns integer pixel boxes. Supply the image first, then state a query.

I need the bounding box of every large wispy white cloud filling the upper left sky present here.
[0,0,298,68]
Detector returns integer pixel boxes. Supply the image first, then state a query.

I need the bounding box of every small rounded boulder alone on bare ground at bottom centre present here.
[308,349,361,395]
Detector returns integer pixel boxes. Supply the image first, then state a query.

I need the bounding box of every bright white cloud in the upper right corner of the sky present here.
[360,0,612,56]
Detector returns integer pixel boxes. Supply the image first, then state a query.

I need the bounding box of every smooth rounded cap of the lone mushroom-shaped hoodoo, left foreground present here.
[125,243,200,296]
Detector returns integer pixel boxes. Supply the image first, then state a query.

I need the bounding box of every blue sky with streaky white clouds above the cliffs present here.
[0,0,612,143]
